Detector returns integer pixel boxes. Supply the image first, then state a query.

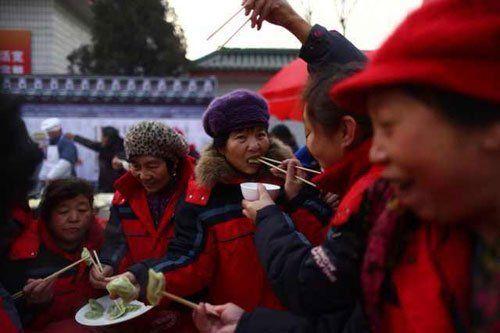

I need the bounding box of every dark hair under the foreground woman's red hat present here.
[403,85,500,129]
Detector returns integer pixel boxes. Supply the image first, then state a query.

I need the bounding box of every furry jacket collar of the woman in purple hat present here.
[195,139,293,189]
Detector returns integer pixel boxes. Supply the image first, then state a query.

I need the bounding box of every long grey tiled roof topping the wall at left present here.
[1,75,217,104]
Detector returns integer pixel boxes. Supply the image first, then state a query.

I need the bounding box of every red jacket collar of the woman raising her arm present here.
[313,140,372,197]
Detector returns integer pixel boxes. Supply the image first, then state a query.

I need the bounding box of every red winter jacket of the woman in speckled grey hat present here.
[101,158,193,274]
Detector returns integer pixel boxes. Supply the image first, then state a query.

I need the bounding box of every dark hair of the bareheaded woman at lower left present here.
[39,178,94,223]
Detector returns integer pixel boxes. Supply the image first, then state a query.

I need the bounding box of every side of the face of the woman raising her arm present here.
[303,107,343,169]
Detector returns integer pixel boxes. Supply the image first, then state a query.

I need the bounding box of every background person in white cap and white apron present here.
[38,118,78,182]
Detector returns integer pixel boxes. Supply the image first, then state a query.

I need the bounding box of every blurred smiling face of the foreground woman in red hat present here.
[368,89,500,222]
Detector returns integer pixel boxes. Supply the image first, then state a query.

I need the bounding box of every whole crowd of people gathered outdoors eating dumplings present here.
[0,0,500,333]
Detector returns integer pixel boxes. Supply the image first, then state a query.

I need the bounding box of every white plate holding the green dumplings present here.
[75,295,153,326]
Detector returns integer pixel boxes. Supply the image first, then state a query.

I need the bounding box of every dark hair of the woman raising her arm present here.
[302,62,372,142]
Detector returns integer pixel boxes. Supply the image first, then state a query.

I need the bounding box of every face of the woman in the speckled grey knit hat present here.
[130,155,171,193]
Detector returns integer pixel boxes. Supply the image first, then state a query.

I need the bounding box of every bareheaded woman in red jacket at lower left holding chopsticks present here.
[1,179,103,331]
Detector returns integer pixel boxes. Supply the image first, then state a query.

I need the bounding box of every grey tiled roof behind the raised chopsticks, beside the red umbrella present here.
[193,48,299,72]
